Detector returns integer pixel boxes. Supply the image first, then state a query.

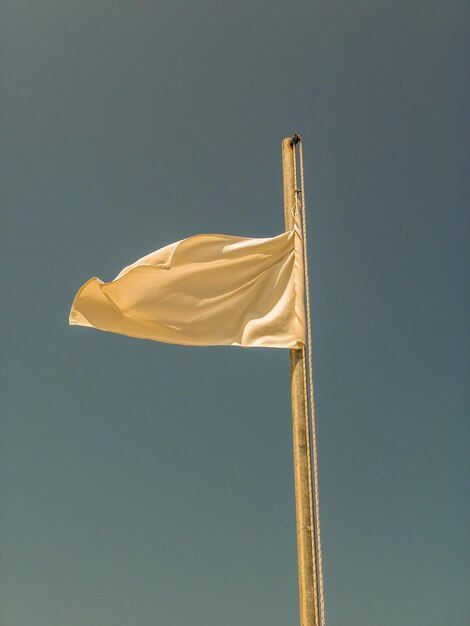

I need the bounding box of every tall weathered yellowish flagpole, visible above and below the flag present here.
[282,135,319,626]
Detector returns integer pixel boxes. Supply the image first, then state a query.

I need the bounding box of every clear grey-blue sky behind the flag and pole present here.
[0,0,470,626]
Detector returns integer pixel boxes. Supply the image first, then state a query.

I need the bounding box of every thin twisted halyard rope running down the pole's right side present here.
[292,135,325,626]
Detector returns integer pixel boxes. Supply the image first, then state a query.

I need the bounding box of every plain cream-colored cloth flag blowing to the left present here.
[69,217,305,348]
